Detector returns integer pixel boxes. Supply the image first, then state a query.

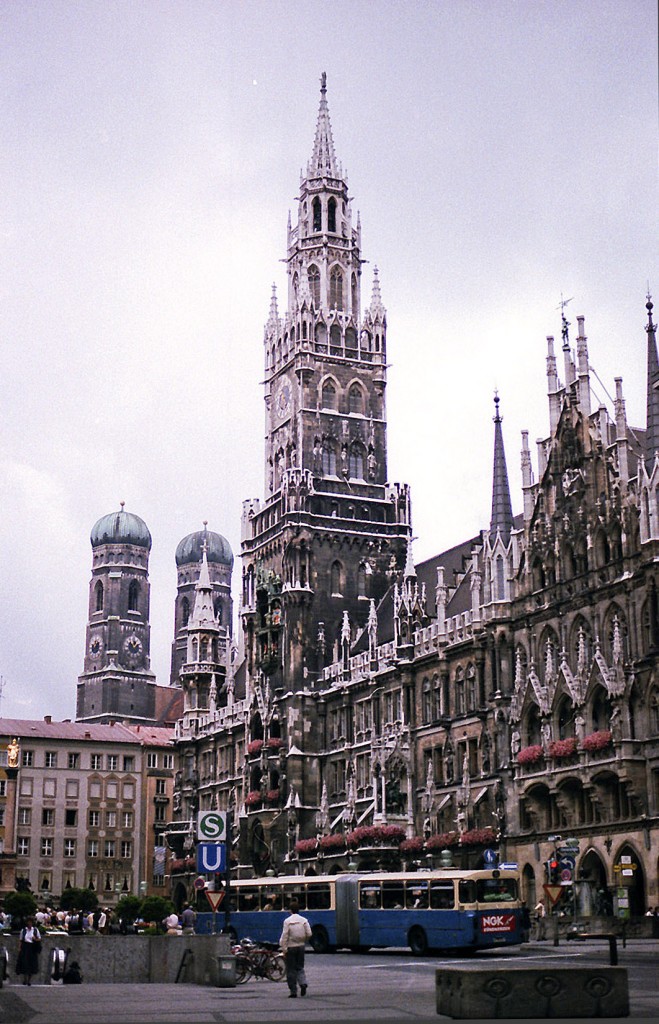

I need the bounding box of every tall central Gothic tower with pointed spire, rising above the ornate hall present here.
[241,74,410,688]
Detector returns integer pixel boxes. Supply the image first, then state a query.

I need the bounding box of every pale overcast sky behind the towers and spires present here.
[0,0,659,718]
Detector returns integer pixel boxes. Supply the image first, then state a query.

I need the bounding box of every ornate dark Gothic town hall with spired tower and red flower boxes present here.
[165,77,659,916]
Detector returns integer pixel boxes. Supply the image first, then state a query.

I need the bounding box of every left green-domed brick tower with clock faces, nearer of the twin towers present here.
[76,502,156,723]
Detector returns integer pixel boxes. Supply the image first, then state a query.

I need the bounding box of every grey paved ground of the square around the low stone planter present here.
[0,940,659,1024]
